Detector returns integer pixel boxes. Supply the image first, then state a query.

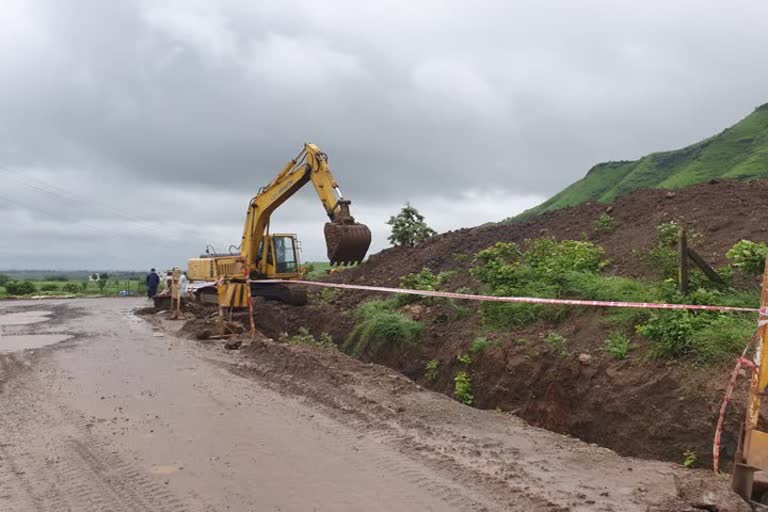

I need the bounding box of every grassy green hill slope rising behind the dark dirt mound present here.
[515,103,768,220]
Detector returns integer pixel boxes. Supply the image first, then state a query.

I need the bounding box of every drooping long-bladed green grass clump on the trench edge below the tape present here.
[344,300,424,357]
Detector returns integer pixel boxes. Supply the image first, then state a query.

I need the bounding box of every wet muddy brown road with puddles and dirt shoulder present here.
[0,299,748,512]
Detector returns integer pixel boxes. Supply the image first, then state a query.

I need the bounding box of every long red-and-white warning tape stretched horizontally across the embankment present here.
[259,279,761,313]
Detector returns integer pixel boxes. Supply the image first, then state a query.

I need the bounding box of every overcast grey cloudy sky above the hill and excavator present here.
[0,0,768,269]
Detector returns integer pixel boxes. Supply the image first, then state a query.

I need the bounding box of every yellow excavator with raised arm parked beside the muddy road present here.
[183,144,371,308]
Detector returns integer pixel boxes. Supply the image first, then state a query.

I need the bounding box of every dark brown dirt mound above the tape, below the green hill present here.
[330,180,768,286]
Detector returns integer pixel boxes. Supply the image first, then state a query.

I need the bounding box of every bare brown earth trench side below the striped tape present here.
[210,302,746,474]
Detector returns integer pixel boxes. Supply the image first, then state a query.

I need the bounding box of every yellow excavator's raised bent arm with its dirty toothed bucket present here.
[240,144,371,269]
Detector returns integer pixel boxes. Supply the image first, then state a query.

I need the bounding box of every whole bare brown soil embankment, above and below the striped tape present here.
[257,180,768,465]
